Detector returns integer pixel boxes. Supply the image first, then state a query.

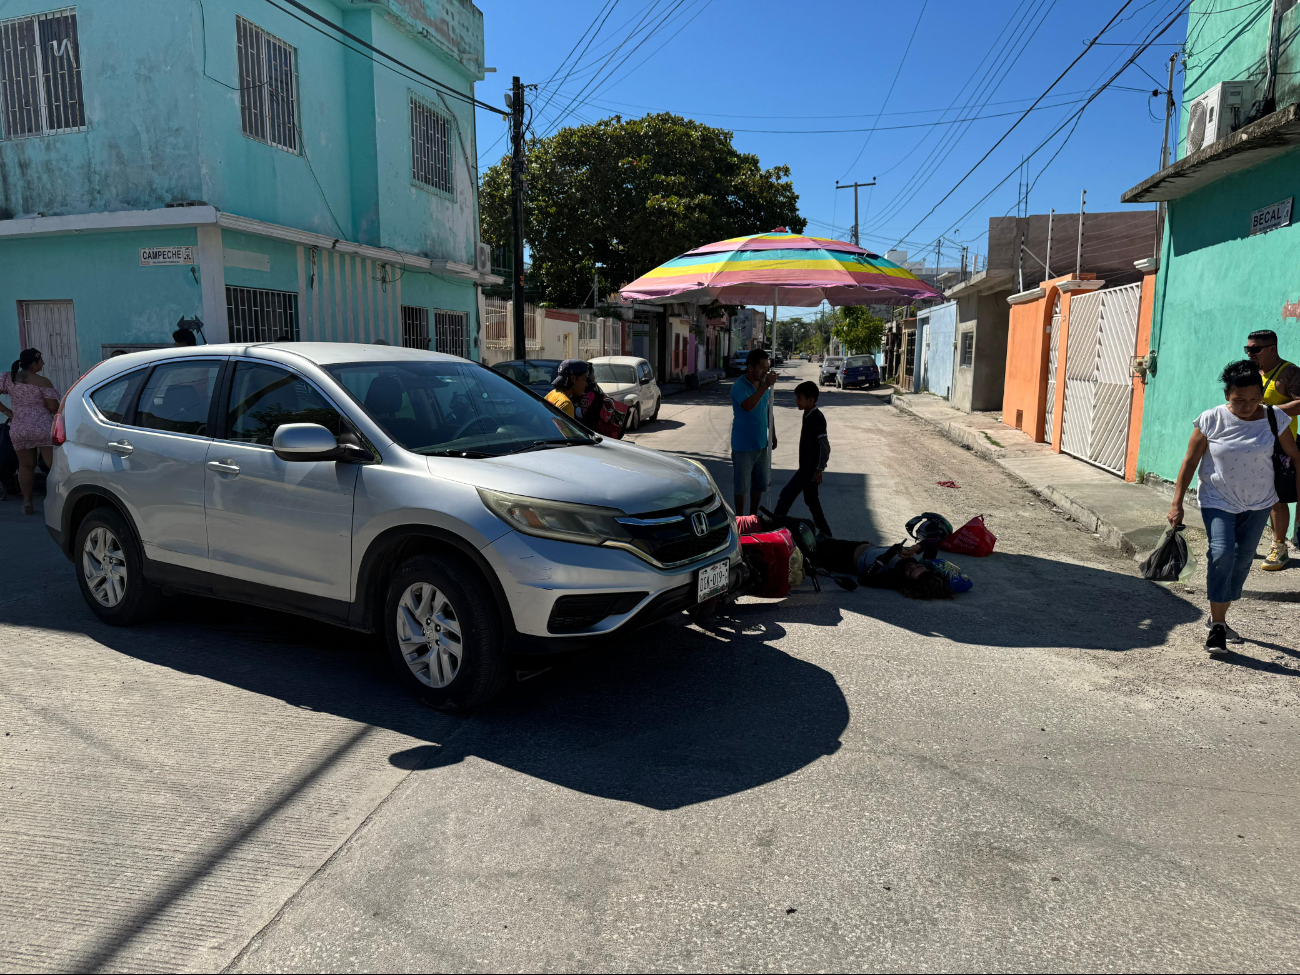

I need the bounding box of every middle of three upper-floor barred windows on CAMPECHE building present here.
[235,17,298,152]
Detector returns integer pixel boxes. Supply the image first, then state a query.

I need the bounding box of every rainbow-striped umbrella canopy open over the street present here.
[620,228,944,307]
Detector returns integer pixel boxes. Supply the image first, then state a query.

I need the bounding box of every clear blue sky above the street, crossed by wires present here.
[477,0,1190,310]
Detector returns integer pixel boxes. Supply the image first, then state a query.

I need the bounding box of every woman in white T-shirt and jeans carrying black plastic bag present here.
[1169,359,1300,657]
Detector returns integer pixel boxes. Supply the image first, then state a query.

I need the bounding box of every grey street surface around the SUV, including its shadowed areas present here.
[0,365,1300,971]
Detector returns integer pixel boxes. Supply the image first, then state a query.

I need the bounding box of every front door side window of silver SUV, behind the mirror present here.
[226,363,343,447]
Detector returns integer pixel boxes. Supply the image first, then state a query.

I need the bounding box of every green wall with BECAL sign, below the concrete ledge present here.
[1138,148,1300,480]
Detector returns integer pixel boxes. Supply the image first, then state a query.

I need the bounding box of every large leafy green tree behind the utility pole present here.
[480,113,806,306]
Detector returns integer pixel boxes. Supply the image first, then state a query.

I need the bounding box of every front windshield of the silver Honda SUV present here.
[326,360,592,456]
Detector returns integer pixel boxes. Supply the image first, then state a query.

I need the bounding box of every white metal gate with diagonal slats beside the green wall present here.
[1061,283,1141,476]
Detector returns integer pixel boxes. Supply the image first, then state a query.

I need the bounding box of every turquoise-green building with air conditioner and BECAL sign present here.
[1122,0,1300,481]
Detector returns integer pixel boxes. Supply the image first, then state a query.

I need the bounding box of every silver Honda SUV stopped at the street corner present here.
[46,343,740,711]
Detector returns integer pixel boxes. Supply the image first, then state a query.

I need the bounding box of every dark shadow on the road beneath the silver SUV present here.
[23,595,849,809]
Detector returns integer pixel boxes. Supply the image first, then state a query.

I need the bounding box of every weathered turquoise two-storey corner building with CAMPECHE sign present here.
[0,0,501,387]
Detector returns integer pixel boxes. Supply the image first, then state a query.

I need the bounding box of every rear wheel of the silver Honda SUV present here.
[73,506,163,627]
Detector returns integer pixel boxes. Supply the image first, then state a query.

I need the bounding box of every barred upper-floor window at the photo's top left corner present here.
[0,7,86,139]
